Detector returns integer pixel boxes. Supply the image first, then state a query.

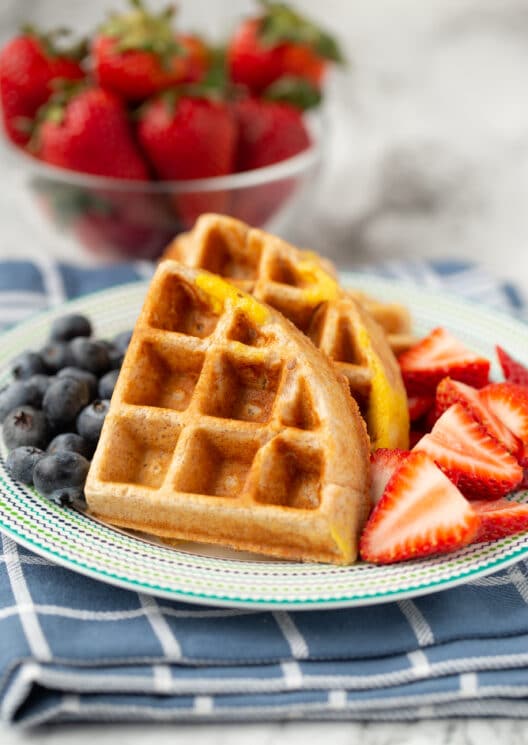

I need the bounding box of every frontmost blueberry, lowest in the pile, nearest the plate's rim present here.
[33,450,90,506]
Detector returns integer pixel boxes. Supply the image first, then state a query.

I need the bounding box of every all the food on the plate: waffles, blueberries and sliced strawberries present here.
[0,215,528,564]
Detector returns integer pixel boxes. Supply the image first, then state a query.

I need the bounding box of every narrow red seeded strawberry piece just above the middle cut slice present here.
[435,378,521,455]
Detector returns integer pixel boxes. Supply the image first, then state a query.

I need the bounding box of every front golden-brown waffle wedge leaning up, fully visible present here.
[85,261,369,564]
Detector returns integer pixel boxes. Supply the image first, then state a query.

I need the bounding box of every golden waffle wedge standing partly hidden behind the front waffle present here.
[165,215,410,449]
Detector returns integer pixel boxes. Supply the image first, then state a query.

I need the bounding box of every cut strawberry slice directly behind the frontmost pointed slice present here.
[413,404,523,499]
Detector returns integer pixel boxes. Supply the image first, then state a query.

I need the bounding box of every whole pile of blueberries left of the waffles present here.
[0,314,132,505]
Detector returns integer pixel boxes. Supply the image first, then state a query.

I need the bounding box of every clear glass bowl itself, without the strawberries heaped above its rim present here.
[6,114,325,261]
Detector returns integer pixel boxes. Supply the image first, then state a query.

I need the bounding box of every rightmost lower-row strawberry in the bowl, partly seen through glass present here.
[231,98,311,226]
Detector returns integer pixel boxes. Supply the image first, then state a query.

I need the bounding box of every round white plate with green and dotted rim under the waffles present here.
[0,274,528,610]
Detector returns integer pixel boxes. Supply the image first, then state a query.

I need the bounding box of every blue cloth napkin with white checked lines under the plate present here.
[0,262,528,726]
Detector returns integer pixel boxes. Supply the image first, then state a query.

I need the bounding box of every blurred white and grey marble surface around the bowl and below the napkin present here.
[0,0,528,745]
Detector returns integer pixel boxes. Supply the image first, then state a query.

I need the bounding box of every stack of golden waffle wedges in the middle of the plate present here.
[86,215,408,564]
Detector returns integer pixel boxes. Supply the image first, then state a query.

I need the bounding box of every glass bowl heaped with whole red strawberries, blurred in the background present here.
[0,0,343,259]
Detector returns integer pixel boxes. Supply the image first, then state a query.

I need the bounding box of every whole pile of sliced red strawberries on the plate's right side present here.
[360,328,528,564]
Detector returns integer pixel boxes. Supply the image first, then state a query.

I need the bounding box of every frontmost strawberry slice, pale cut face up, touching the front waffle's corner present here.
[359,453,479,564]
